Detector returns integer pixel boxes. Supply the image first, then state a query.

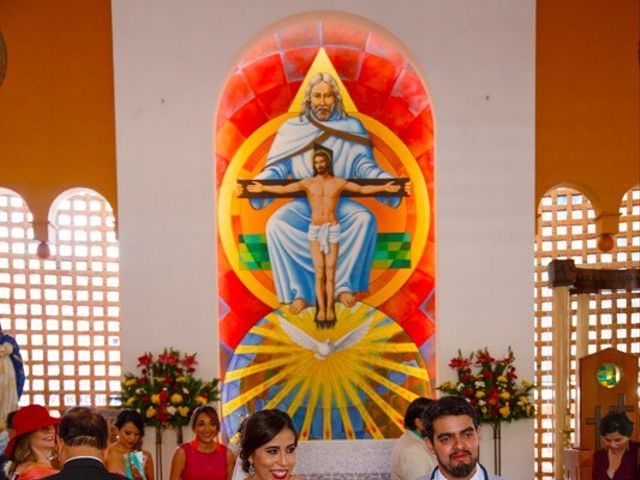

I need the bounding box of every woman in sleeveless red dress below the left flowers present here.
[169,406,234,480]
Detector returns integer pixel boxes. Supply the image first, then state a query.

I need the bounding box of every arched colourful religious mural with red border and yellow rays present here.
[216,20,435,439]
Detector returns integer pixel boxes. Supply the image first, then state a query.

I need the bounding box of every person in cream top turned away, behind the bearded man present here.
[391,397,438,480]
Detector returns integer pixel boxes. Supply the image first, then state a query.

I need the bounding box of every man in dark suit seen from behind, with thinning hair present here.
[45,407,126,480]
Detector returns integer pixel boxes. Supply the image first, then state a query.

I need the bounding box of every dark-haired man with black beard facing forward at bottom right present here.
[420,397,500,480]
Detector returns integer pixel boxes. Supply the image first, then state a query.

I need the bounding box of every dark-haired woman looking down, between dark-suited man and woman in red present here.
[105,409,153,480]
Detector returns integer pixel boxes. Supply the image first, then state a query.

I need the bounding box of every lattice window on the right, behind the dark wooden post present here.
[534,187,640,479]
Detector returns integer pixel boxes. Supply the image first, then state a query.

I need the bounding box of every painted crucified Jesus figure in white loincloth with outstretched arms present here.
[246,150,403,328]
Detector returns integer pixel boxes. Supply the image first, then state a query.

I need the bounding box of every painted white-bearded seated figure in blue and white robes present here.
[251,69,401,314]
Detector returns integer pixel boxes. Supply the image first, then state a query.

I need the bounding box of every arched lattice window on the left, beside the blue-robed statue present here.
[0,189,121,410]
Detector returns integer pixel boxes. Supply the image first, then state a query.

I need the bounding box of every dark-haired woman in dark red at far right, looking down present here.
[592,412,640,480]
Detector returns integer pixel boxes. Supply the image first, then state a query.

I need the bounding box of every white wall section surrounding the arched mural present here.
[112,0,535,479]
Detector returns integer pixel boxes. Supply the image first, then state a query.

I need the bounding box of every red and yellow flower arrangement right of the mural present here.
[437,347,535,426]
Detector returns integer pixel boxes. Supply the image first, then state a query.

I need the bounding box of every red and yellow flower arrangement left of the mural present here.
[120,348,220,428]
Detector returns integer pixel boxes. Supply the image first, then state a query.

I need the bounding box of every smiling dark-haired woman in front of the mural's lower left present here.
[240,410,301,480]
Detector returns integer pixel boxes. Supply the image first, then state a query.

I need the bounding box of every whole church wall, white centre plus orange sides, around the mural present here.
[0,0,640,478]
